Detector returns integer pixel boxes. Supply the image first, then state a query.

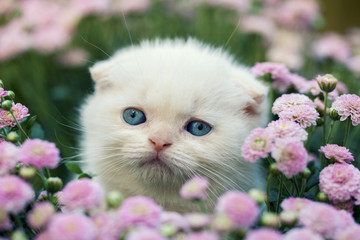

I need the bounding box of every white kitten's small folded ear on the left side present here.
[90,60,114,90]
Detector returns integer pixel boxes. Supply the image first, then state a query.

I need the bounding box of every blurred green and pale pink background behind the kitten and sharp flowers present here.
[0,0,360,178]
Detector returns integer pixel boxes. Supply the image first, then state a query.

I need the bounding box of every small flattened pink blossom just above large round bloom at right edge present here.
[319,144,354,163]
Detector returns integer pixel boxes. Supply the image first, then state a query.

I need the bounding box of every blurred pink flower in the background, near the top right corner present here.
[312,33,351,62]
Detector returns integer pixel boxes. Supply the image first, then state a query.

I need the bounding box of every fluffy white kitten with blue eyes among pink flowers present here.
[82,39,267,211]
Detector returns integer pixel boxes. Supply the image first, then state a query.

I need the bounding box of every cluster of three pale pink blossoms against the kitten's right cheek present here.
[241,119,308,178]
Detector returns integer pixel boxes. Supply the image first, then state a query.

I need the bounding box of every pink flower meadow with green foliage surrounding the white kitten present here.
[0,0,360,240]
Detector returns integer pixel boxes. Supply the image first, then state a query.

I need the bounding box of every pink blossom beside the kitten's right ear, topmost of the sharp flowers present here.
[251,62,289,79]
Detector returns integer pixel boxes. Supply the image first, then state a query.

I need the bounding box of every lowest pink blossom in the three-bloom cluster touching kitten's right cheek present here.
[271,139,308,178]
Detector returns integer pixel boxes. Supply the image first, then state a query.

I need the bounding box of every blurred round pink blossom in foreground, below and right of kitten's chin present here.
[216,191,260,228]
